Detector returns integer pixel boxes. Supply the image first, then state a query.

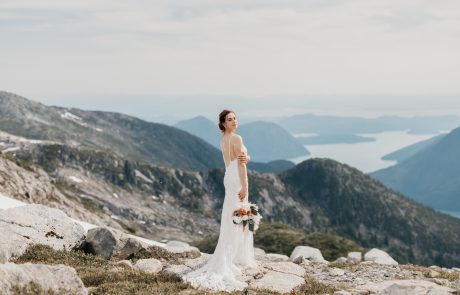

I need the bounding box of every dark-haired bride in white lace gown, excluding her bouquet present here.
[183,110,257,291]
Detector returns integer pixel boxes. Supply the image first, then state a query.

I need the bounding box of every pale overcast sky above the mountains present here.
[0,0,460,122]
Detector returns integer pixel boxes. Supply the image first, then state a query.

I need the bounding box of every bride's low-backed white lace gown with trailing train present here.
[183,148,258,292]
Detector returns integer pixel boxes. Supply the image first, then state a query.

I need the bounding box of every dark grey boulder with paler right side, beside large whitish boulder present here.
[85,227,147,259]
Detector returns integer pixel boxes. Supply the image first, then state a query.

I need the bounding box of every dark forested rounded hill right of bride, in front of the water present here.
[280,160,460,266]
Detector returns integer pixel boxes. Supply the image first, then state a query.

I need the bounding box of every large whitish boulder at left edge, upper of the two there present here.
[0,204,85,263]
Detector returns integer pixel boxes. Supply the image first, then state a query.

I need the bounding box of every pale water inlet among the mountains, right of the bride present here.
[290,131,437,173]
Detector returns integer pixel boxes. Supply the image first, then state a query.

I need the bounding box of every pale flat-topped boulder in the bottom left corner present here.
[0,263,88,295]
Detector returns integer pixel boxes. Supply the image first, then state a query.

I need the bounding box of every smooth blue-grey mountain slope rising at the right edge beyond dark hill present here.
[371,128,460,211]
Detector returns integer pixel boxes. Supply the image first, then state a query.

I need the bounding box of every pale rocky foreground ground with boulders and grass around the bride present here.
[0,205,460,295]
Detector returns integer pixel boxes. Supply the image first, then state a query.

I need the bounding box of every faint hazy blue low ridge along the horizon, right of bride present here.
[278,114,460,134]
